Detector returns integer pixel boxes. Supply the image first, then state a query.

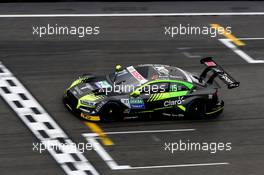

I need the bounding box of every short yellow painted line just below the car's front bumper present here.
[84,122,114,146]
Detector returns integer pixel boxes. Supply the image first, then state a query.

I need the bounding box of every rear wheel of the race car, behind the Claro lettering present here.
[186,100,206,118]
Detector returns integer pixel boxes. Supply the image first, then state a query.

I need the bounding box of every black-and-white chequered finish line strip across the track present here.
[0,62,99,175]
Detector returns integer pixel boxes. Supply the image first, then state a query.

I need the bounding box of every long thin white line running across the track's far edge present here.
[0,12,264,18]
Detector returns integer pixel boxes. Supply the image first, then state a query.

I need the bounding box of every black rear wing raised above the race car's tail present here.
[200,57,240,89]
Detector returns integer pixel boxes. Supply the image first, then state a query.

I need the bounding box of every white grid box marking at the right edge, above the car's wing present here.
[219,38,264,64]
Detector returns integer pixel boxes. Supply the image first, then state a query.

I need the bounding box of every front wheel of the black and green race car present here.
[100,102,122,122]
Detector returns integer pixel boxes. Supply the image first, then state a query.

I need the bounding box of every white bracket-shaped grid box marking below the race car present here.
[82,129,229,170]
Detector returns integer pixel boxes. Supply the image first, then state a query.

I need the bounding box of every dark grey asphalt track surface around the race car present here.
[0,2,264,175]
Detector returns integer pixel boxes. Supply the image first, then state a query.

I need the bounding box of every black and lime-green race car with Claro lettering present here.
[63,57,240,122]
